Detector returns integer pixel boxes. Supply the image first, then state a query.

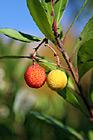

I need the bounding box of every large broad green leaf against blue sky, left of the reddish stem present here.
[27,0,55,42]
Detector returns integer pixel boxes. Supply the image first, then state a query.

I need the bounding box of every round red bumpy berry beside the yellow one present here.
[24,65,46,88]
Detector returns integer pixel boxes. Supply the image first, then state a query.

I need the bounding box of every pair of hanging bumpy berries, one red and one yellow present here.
[24,65,67,91]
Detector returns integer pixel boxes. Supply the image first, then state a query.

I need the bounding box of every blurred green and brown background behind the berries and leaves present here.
[0,0,93,140]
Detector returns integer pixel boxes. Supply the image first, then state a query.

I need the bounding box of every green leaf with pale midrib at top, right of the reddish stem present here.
[54,0,68,26]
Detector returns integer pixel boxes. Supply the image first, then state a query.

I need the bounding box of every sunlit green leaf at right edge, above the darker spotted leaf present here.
[73,17,93,52]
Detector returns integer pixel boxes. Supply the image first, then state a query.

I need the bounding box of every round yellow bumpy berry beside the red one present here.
[47,70,67,91]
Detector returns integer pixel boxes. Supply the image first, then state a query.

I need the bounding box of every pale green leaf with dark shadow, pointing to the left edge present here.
[0,28,42,43]
